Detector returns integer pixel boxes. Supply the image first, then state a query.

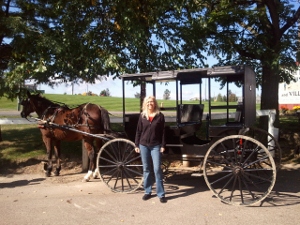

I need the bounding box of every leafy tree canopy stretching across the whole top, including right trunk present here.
[0,0,300,125]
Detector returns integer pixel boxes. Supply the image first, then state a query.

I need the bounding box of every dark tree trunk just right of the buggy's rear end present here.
[259,65,279,128]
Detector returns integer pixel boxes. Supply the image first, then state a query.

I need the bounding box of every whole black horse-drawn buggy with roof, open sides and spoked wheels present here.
[97,66,281,205]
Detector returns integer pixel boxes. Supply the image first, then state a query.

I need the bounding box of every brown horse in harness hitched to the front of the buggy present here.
[21,92,110,181]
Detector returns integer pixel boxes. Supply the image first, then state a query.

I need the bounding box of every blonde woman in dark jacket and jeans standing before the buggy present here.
[135,96,167,203]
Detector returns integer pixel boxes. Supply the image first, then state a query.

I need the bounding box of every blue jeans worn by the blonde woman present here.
[139,145,165,198]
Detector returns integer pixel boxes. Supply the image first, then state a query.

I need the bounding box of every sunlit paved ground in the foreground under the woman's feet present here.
[0,163,300,225]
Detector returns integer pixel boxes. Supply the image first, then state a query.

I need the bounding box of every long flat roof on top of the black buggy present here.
[121,66,246,84]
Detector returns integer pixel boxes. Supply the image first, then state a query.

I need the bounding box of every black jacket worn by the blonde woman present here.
[135,113,166,147]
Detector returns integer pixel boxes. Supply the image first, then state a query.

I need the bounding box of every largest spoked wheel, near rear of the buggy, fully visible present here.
[203,135,276,205]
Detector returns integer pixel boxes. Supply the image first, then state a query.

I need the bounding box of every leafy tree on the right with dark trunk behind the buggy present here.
[191,0,300,125]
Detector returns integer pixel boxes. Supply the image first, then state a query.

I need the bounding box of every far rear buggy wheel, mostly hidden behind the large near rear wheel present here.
[239,127,282,171]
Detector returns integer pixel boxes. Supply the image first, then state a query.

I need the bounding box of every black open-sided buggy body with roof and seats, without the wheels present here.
[122,66,256,160]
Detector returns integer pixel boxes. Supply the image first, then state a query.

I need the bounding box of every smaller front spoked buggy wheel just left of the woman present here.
[97,138,143,192]
